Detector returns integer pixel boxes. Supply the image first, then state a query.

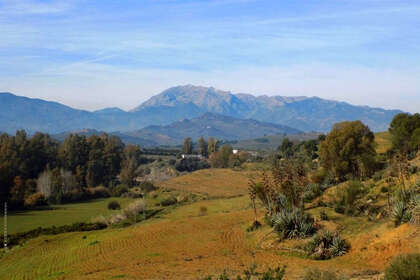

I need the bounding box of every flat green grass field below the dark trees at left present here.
[0,198,133,234]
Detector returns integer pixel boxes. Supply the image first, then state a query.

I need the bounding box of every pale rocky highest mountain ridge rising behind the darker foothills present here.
[132,85,402,132]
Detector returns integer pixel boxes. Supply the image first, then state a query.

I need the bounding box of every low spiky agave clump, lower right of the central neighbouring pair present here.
[305,231,350,260]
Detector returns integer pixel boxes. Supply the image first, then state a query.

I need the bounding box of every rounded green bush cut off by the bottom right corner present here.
[385,254,420,280]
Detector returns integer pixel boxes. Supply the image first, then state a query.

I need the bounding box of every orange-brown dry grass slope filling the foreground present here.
[0,197,420,279]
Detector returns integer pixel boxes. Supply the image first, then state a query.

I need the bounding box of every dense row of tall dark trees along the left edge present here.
[0,130,144,208]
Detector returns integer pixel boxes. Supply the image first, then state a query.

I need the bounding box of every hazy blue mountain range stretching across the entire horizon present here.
[0,85,401,139]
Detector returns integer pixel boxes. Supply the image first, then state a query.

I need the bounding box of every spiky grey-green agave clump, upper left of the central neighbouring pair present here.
[273,208,315,239]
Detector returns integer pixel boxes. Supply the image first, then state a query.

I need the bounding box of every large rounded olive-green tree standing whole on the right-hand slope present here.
[319,121,376,180]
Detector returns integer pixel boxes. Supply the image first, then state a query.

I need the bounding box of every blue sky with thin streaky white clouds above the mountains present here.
[0,0,420,112]
